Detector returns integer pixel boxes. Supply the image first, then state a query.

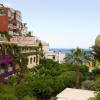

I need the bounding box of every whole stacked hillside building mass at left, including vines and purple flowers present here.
[0,4,42,81]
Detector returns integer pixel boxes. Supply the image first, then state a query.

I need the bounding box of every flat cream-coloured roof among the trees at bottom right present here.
[56,88,95,100]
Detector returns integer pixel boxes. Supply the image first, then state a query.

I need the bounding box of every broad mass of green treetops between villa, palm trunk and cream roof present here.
[0,59,90,100]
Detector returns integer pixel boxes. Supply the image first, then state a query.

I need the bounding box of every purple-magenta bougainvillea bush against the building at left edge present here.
[0,54,15,79]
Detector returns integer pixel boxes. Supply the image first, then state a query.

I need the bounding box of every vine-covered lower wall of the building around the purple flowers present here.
[0,42,40,81]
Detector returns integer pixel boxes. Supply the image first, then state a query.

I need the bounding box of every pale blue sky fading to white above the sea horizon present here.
[0,0,100,49]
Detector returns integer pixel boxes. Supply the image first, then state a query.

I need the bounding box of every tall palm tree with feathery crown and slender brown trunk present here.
[65,48,90,88]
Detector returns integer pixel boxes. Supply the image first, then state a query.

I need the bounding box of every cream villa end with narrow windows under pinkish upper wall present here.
[10,35,41,68]
